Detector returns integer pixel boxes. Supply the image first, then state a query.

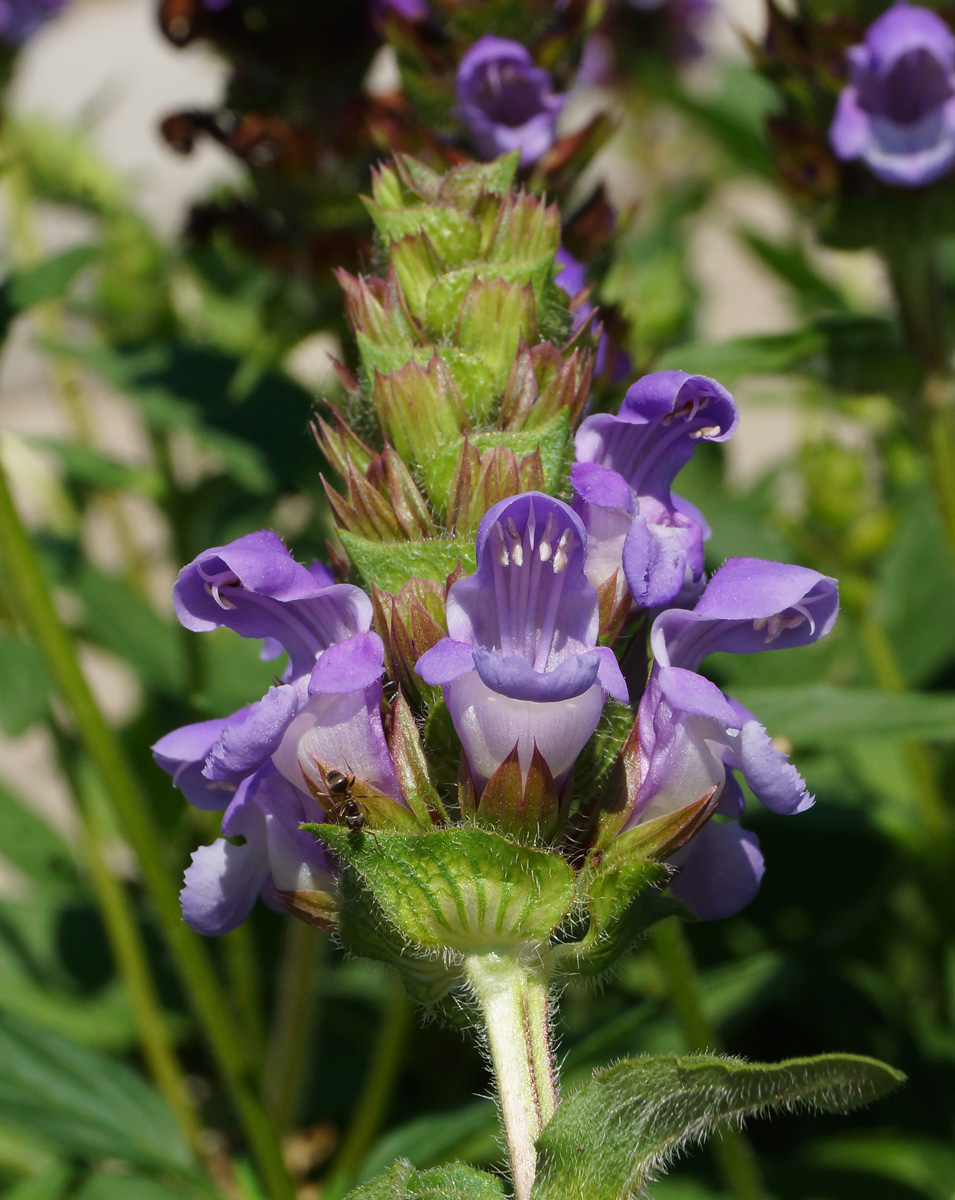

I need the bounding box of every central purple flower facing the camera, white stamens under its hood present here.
[415,492,627,787]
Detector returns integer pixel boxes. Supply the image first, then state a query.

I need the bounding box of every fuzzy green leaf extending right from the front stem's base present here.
[531,1055,905,1200]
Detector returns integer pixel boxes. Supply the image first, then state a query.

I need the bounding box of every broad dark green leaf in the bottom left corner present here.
[0,1013,192,1172]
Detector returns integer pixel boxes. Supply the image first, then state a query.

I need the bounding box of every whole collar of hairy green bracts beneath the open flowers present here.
[304,821,681,1024]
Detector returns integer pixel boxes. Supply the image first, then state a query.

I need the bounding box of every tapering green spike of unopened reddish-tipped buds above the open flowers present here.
[316,154,596,592]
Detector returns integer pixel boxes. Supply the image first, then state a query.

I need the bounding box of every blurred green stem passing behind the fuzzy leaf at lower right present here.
[651,917,765,1200]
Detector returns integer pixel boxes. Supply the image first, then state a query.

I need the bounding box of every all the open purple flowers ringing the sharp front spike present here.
[154,371,837,935]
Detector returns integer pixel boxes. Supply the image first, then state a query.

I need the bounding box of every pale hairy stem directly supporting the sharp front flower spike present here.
[466,950,557,1200]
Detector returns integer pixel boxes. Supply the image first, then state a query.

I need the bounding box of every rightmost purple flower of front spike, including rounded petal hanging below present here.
[627,558,839,919]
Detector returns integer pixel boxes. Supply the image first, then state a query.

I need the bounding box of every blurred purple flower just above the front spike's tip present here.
[457,34,564,167]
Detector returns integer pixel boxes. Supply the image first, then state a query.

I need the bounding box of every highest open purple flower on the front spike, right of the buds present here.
[571,371,739,608]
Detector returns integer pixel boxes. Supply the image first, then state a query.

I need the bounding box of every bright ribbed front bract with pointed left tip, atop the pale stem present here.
[316,826,576,953]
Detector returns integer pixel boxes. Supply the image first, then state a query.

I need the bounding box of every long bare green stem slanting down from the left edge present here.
[0,464,294,1200]
